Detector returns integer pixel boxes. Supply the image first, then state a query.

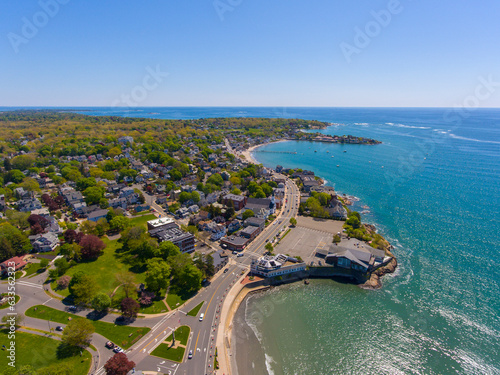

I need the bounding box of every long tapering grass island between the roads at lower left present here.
[26,305,151,349]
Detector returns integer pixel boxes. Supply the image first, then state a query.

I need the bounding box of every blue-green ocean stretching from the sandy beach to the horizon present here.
[5,107,500,375]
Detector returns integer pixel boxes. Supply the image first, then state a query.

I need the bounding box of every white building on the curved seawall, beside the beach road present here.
[250,254,306,277]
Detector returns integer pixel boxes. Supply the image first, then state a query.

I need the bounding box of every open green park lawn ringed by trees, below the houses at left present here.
[52,238,149,297]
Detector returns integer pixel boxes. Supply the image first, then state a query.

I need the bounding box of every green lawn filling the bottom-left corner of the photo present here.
[0,330,92,374]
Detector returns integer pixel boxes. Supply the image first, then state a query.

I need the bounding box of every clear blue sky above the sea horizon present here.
[0,0,500,107]
